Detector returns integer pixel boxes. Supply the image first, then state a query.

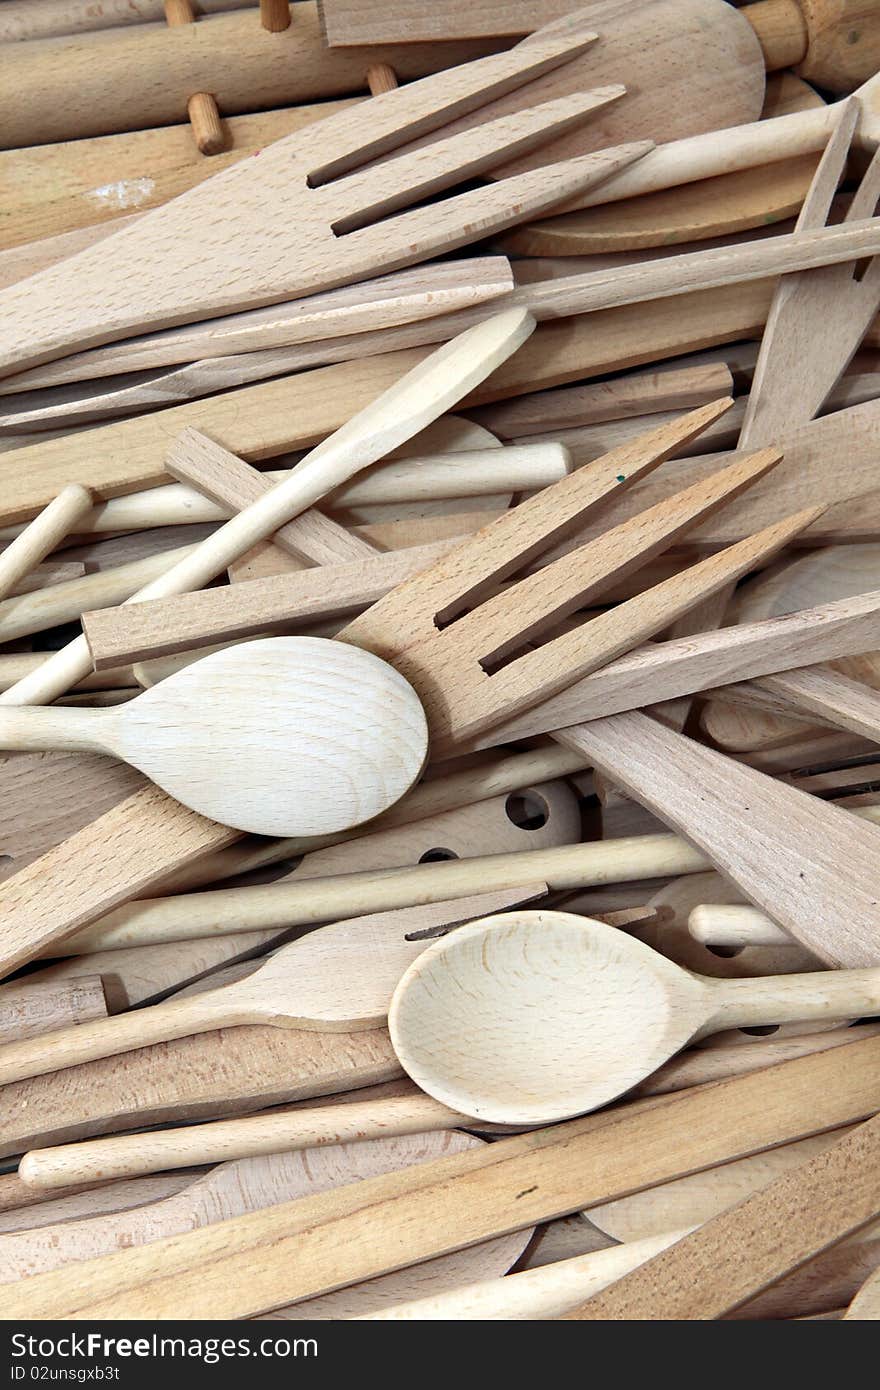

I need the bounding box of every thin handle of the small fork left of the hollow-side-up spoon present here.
[0,991,229,1086]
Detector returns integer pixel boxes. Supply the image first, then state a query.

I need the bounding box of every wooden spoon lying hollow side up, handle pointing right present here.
[388,912,880,1125]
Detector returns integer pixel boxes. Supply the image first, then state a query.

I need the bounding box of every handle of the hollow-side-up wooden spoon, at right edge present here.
[701,969,880,1036]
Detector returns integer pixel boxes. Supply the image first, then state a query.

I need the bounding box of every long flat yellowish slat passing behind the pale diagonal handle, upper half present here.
[0,281,784,525]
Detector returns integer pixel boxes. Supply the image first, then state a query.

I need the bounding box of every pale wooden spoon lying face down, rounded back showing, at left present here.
[0,637,428,835]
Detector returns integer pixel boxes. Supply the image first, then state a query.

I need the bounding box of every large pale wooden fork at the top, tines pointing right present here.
[0,36,649,373]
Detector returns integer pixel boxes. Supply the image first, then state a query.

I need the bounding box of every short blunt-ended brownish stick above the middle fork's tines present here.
[471,363,733,439]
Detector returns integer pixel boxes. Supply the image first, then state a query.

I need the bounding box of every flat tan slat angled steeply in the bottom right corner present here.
[566,1116,880,1321]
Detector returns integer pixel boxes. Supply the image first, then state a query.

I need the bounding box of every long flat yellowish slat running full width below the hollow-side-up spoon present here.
[4,1038,880,1318]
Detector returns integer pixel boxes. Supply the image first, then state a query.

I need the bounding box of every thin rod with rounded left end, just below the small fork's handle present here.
[18,1089,473,1188]
